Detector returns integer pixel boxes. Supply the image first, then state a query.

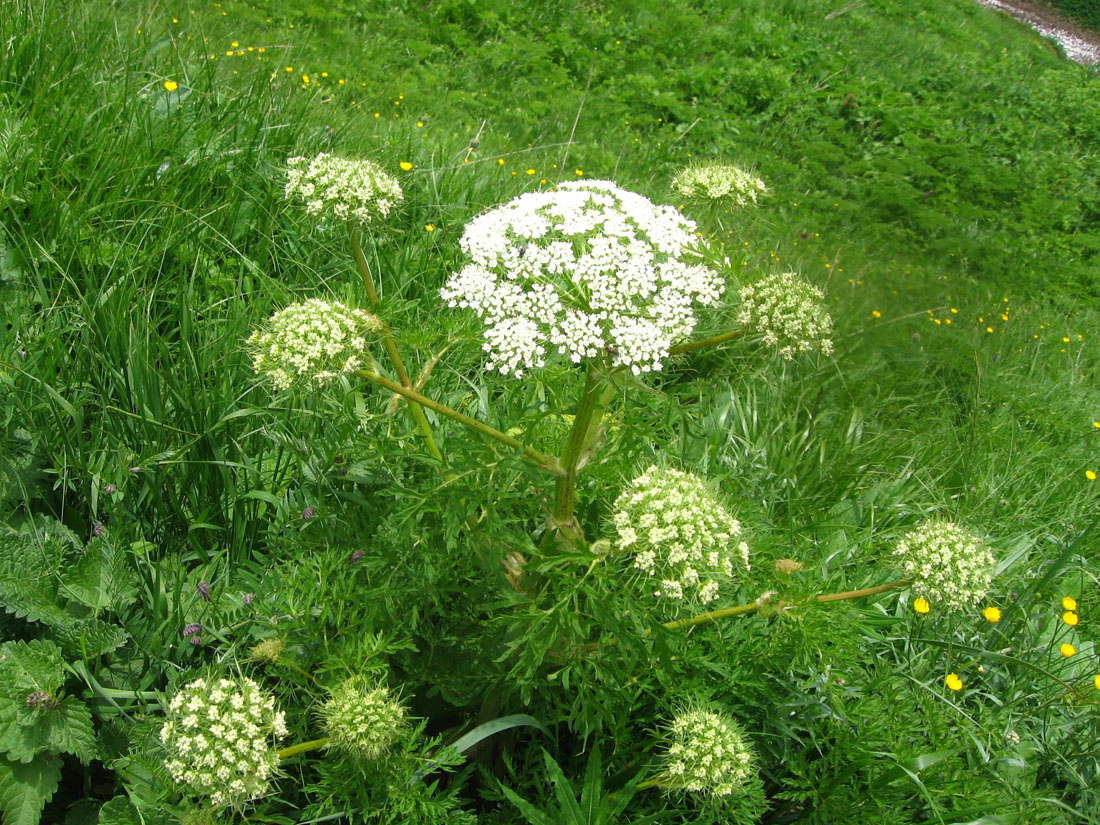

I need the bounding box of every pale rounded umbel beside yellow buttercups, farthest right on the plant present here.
[893,519,993,612]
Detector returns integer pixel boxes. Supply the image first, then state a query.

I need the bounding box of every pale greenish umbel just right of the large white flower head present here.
[737,272,833,361]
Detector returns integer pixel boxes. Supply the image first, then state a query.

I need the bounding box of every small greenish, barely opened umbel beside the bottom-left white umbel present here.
[320,677,405,759]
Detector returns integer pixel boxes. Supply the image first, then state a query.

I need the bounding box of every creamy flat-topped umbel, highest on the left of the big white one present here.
[286,152,404,223]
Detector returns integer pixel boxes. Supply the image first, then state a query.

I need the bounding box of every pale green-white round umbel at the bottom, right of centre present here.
[663,710,756,796]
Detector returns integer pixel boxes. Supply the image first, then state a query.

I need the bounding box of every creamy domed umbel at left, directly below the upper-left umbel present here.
[246,298,382,389]
